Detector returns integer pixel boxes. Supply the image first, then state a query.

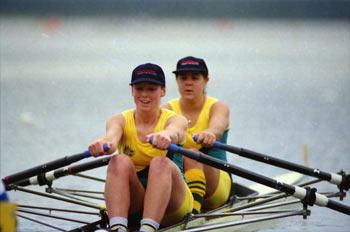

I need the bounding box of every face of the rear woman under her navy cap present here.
[176,72,209,99]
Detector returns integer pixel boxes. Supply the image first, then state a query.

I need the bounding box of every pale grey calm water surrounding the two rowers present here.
[0,17,350,232]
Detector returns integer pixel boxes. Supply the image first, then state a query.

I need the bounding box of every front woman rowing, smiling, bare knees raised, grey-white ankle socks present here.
[89,63,193,232]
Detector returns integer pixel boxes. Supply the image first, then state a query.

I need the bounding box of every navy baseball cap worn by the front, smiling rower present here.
[130,63,165,87]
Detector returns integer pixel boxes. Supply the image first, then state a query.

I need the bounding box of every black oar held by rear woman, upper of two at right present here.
[194,136,350,191]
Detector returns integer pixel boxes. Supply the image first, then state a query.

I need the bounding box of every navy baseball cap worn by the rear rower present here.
[173,56,208,76]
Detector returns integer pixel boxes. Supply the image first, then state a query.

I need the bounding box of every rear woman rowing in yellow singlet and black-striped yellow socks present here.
[163,56,231,213]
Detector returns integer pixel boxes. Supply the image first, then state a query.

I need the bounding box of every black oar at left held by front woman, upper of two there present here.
[3,144,108,185]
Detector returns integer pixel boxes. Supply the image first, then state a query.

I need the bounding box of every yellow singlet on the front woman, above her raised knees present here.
[118,109,182,172]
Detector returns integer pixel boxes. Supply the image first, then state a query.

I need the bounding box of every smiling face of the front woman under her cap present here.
[132,82,166,110]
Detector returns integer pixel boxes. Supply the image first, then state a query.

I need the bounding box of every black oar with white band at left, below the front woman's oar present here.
[7,156,113,189]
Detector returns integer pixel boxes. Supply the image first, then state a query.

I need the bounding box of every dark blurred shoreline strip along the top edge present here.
[0,0,350,19]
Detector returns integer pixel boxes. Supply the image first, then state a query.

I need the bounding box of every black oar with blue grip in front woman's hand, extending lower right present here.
[159,139,350,215]
